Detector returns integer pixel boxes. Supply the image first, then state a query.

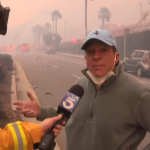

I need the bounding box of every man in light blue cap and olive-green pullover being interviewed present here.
[13,30,150,150]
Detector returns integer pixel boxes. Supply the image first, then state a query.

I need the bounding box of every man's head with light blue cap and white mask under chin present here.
[81,29,119,86]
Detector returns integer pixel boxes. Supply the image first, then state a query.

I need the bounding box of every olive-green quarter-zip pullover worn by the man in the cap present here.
[39,64,150,150]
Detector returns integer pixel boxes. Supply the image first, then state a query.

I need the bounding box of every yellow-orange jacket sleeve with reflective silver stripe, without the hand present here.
[0,121,43,150]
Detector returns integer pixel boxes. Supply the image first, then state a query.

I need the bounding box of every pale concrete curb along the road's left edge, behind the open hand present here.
[12,60,61,150]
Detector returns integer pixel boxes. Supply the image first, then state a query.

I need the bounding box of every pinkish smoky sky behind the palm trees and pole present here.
[1,0,150,38]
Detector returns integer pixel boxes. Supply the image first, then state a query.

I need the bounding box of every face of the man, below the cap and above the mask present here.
[85,40,119,77]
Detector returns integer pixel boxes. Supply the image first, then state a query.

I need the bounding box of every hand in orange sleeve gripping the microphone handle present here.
[40,114,65,137]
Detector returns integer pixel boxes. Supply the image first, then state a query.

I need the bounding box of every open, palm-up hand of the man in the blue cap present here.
[13,92,41,117]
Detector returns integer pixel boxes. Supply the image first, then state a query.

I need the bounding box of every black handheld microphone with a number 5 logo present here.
[39,85,84,150]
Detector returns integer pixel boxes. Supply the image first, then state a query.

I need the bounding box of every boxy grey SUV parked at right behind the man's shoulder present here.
[122,50,150,77]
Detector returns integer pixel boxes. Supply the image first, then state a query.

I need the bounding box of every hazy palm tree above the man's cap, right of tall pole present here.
[98,7,111,28]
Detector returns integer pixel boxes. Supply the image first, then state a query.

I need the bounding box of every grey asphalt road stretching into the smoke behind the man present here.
[11,52,150,150]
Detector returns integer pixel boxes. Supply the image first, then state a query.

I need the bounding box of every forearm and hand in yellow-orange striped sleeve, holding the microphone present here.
[0,115,64,150]
